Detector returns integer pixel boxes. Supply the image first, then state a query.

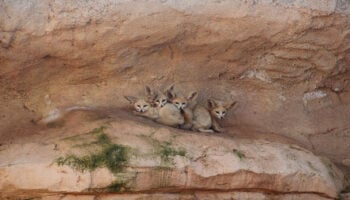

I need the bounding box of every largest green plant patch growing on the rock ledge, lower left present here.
[56,126,128,173]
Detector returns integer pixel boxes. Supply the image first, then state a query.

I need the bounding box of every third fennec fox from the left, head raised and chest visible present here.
[167,92,198,129]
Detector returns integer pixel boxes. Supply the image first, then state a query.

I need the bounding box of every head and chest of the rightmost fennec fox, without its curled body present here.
[208,99,237,132]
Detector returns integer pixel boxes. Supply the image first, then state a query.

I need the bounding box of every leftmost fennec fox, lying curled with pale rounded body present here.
[125,86,184,127]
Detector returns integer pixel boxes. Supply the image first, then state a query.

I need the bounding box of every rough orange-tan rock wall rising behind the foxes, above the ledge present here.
[0,0,350,199]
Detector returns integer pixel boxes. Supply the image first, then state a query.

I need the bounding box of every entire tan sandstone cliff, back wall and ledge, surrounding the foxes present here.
[0,0,350,199]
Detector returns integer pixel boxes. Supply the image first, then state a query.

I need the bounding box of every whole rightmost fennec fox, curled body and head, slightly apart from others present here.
[192,99,237,133]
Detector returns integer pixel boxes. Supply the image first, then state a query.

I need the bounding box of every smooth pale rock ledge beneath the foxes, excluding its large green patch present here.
[0,115,343,199]
